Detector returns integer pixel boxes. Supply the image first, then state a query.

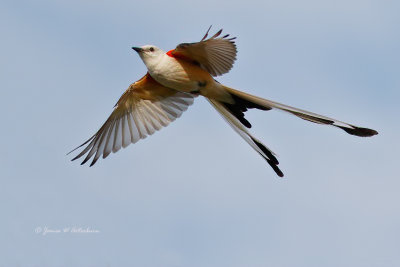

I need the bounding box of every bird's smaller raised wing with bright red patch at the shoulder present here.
[169,26,237,76]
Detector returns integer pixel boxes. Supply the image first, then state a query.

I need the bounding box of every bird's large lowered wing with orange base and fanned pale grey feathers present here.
[68,73,193,166]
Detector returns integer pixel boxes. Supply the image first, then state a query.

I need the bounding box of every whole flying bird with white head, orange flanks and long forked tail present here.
[68,27,378,177]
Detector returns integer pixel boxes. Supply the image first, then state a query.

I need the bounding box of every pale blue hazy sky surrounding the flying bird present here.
[0,0,400,267]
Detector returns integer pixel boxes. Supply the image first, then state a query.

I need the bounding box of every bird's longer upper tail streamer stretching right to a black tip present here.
[224,86,378,137]
